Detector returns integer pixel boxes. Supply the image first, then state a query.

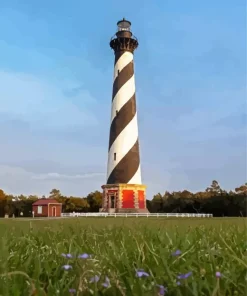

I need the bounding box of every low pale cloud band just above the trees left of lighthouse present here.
[0,165,105,196]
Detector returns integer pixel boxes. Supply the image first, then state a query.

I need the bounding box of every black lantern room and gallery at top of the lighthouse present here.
[110,18,138,53]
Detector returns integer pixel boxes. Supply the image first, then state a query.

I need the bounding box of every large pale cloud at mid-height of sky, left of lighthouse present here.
[0,71,97,129]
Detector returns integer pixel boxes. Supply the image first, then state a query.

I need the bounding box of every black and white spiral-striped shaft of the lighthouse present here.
[107,51,141,184]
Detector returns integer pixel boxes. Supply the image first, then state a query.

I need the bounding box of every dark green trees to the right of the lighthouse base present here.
[147,180,247,217]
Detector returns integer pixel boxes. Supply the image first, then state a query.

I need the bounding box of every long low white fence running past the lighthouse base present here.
[61,213,213,218]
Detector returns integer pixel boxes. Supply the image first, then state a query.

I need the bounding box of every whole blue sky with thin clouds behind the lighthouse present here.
[0,0,247,198]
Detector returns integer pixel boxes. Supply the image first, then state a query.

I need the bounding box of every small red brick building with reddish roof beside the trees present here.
[32,198,62,217]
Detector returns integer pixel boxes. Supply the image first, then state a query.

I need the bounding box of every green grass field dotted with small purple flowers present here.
[0,218,247,296]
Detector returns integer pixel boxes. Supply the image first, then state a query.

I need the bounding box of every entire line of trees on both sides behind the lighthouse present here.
[0,180,247,217]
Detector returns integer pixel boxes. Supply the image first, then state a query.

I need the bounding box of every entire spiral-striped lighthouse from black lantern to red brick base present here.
[102,19,147,213]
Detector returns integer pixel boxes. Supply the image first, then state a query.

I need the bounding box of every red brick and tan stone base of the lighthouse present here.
[101,184,148,213]
